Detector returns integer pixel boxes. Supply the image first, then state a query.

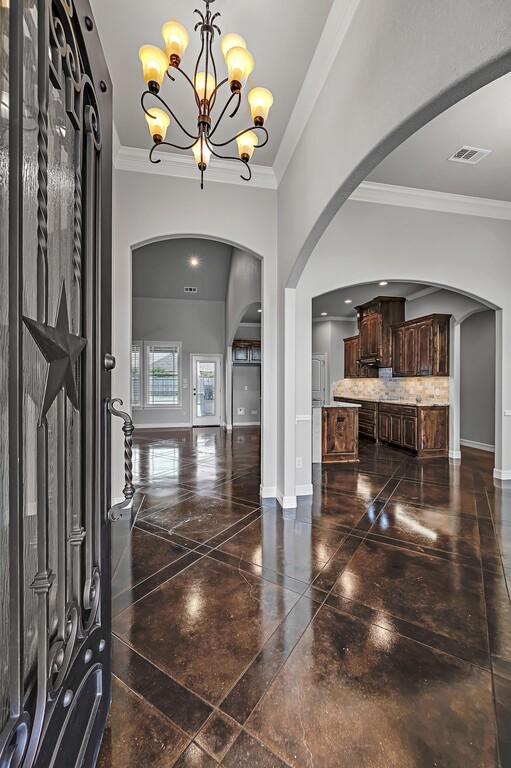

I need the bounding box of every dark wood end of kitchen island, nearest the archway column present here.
[321,407,358,464]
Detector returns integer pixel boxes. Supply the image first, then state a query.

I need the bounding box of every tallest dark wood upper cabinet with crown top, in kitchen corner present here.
[356,296,406,368]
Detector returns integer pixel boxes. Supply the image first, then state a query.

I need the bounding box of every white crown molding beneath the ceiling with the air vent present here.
[350,181,511,220]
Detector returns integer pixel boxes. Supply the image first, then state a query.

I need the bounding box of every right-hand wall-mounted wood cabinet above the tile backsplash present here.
[392,315,451,376]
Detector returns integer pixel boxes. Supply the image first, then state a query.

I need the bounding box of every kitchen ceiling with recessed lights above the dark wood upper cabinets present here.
[312,277,426,320]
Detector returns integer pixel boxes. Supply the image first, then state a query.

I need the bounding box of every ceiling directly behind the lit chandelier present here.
[91,0,333,166]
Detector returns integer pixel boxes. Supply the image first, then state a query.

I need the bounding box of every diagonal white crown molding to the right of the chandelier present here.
[273,0,360,183]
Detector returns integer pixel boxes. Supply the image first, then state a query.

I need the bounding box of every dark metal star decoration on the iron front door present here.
[23,282,87,424]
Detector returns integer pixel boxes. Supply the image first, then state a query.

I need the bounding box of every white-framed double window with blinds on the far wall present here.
[131,341,181,408]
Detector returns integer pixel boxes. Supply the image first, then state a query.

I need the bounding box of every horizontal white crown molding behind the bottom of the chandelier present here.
[114,144,277,189]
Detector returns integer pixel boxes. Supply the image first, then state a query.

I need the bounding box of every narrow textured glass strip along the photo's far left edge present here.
[0,4,9,731]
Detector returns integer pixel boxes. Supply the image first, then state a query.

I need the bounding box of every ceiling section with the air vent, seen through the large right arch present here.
[368,74,511,201]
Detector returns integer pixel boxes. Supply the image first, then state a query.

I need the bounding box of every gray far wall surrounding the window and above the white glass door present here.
[133,298,225,426]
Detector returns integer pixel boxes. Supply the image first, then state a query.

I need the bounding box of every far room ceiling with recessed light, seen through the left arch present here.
[132,238,232,301]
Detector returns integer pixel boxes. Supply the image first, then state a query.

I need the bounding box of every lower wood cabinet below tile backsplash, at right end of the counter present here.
[378,403,449,458]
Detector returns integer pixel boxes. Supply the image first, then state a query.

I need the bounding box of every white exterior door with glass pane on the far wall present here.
[191,355,222,427]
